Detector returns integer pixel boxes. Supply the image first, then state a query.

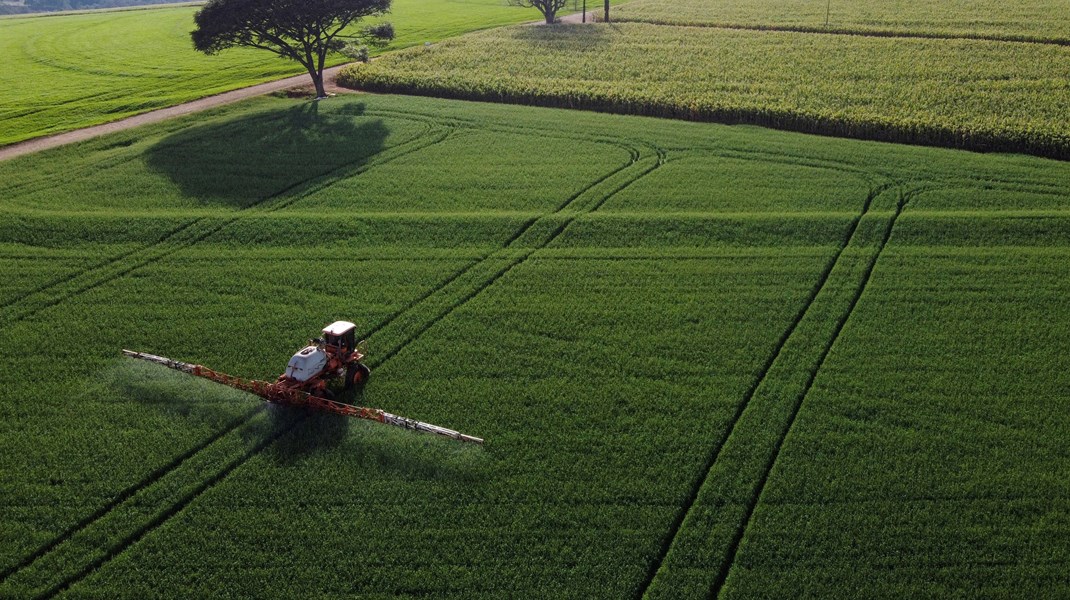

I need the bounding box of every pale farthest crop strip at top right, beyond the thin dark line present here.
[612,0,1070,44]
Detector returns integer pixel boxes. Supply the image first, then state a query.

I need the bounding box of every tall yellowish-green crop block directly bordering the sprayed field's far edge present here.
[339,7,1070,158]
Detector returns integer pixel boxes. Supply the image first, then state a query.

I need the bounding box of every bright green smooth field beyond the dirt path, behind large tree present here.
[0,0,552,145]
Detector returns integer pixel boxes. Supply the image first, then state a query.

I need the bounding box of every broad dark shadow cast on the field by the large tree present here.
[147,102,389,209]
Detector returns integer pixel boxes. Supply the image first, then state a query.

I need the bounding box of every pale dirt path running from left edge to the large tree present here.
[0,64,356,160]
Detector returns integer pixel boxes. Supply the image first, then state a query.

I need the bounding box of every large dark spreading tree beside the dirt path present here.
[192,0,394,98]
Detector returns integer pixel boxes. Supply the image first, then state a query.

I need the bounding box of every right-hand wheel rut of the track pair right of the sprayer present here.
[708,188,928,598]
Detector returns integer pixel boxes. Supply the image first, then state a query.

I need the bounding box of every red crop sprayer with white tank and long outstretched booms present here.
[123,321,483,444]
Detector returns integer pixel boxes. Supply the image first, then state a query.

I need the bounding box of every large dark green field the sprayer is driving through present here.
[0,95,1070,598]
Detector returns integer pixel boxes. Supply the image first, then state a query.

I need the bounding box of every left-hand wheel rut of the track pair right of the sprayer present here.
[635,178,895,598]
